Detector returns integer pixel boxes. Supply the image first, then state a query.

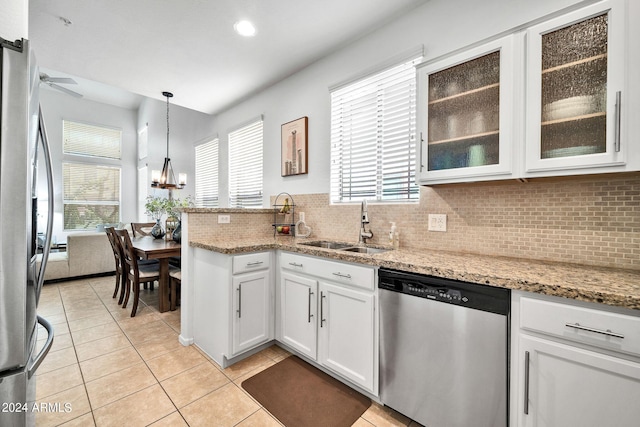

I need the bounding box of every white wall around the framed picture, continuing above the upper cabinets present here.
[214,0,620,206]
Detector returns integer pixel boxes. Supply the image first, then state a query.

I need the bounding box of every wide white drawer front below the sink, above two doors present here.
[280,252,375,291]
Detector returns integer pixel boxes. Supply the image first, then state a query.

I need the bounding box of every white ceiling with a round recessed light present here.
[29,0,428,114]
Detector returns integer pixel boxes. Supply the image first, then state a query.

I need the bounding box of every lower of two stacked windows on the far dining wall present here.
[62,163,120,230]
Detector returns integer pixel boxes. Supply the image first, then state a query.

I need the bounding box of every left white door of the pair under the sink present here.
[280,271,318,360]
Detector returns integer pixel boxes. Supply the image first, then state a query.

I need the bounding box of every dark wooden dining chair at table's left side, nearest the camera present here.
[115,230,160,317]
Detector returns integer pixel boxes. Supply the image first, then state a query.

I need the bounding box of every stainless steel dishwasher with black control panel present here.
[378,269,510,427]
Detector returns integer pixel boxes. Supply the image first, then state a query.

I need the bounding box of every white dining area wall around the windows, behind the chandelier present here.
[40,88,213,241]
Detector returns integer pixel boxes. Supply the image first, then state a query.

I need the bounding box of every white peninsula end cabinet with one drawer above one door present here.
[193,248,274,367]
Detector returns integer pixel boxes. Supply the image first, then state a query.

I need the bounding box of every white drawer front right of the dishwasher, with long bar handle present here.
[520,298,640,356]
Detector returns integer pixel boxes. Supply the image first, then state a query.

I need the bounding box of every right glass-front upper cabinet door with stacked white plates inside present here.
[526,0,626,175]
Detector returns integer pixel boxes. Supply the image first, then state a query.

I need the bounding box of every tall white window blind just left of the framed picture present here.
[229,119,262,208]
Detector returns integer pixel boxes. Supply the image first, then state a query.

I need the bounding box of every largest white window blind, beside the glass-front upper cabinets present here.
[331,58,421,203]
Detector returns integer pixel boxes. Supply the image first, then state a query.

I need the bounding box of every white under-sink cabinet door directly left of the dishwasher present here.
[319,282,375,390]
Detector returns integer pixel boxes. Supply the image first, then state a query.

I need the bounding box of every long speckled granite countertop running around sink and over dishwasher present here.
[189,237,640,310]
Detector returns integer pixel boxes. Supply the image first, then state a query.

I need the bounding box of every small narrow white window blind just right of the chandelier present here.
[195,138,218,208]
